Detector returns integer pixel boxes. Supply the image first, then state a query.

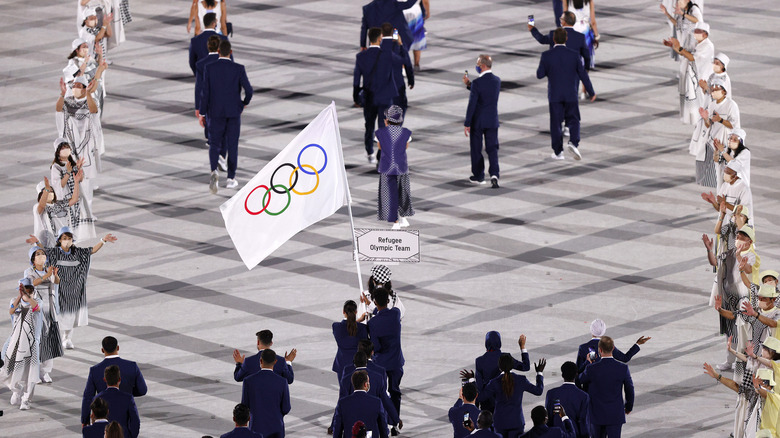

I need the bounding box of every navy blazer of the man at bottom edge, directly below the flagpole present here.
[333,391,387,438]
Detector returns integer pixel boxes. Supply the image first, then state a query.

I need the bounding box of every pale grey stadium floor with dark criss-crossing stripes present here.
[0,0,780,437]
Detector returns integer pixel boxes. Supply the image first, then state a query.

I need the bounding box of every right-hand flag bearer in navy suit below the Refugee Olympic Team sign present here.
[368,287,405,432]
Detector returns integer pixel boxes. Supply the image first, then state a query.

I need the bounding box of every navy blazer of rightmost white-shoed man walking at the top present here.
[536,45,596,102]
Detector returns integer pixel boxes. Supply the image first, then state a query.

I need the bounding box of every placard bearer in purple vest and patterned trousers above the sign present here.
[375,105,414,230]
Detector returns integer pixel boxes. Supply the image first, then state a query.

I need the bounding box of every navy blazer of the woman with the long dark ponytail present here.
[477,374,544,431]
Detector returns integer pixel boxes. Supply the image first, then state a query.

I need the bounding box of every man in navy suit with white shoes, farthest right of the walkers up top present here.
[536,27,596,160]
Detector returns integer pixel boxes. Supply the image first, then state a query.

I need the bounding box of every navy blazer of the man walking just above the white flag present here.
[200,58,252,118]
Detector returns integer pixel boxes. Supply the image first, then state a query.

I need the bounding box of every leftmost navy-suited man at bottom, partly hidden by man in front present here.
[81,336,146,426]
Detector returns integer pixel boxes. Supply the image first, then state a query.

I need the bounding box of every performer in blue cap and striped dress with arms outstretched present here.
[27,227,117,350]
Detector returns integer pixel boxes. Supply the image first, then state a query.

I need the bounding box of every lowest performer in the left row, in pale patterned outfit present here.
[0,277,42,410]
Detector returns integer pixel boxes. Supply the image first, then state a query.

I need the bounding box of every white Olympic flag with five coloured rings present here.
[219,102,350,269]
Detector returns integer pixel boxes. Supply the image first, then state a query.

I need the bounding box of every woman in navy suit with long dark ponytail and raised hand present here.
[479,353,547,438]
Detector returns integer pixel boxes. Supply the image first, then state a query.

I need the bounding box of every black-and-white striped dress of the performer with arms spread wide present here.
[44,246,92,331]
